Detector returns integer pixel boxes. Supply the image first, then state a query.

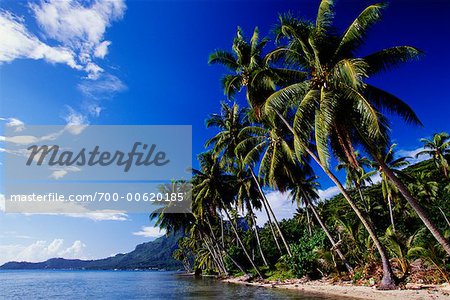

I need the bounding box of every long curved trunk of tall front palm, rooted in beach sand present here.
[275,110,396,289]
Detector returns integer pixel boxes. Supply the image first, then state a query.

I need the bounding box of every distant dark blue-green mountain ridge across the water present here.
[0,234,183,270]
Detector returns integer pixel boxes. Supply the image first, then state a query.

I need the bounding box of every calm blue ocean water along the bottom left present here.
[0,270,348,300]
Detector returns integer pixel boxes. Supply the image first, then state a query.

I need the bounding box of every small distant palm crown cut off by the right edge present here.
[416,132,450,178]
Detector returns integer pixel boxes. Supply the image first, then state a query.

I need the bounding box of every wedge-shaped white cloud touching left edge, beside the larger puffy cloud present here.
[0,10,82,70]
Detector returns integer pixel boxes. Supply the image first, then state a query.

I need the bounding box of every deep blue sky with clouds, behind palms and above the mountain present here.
[0,0,450,263]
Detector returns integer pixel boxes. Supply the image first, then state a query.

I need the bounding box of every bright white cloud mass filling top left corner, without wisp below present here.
[0,0,126,80]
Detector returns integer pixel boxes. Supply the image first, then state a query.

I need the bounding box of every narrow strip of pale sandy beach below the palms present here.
[221,277,450,300]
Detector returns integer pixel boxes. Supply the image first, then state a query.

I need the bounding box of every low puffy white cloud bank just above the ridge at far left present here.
[0,239,86,265]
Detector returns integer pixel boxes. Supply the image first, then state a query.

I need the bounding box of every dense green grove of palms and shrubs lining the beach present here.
[151,0,450,289]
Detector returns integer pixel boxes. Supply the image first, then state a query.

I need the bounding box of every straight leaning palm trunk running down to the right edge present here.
[375,158,450,255]
